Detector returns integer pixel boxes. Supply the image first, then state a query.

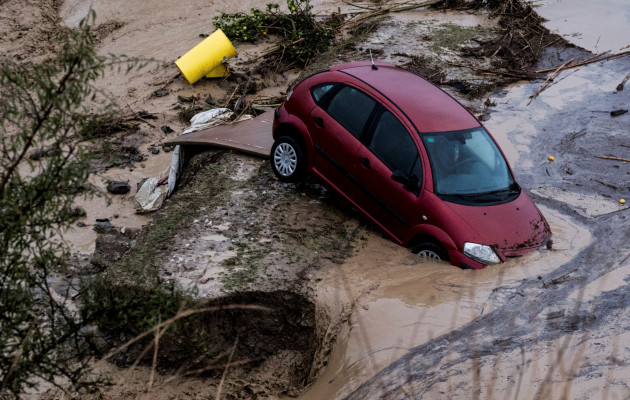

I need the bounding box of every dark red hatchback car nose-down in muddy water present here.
[271,62,551,269]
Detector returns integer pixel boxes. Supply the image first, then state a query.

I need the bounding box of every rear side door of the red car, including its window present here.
[307,84,376,195]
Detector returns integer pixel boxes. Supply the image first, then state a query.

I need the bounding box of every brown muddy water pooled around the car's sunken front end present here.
[300,208,592,400]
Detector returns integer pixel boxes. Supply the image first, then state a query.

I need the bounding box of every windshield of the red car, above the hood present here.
[421,127,520,202]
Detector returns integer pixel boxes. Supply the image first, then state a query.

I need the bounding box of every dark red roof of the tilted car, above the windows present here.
[330,61,481,132]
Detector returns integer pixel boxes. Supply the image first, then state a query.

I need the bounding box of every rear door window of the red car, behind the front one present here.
[326,86,376,139]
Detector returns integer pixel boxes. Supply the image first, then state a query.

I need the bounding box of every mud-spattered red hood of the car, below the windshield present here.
[448,190,551,261]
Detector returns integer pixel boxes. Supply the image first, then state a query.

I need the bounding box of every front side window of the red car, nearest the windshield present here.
[368,110,422,181]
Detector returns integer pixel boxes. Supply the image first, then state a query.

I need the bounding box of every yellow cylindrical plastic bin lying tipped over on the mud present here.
[175,29,236,85]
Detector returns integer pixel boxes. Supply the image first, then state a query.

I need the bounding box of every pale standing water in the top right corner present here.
[535,0,630,53]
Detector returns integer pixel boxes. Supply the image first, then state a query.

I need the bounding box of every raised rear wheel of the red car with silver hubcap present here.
[270,136,306,182]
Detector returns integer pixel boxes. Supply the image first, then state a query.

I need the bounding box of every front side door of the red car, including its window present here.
[353,106,423,242]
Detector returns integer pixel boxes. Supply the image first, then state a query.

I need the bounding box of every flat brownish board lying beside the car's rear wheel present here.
[166,110,273,158]
